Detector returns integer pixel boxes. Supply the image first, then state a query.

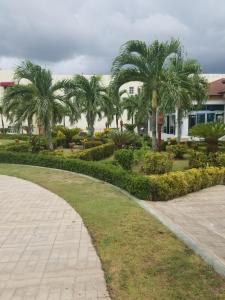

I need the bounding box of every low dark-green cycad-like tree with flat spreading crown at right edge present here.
[189,122,225,153]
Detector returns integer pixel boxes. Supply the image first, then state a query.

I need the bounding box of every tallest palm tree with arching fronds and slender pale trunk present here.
[112,39,180,150]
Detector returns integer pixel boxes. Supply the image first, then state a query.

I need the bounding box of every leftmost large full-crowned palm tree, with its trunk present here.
[3,61,69,149]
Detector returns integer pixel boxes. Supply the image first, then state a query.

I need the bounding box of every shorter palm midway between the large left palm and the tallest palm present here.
[62,75,106,135]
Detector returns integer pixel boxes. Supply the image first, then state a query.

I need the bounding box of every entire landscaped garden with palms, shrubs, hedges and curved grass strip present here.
[0,40,225,299]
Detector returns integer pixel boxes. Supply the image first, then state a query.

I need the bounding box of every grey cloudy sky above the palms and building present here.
[0,0,225,74]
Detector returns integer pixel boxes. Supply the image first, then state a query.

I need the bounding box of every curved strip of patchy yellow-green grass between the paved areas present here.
[0,164,225,300]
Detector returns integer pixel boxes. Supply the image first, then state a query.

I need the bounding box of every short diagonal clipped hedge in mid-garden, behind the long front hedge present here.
[74,143,115,160]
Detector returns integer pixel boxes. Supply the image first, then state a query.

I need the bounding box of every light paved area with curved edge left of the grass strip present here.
[0,175,109,300]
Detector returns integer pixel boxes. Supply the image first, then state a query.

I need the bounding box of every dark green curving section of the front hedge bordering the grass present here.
[0,151,151,200]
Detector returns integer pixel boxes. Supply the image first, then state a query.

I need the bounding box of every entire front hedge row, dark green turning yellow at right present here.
[0,151,225,201]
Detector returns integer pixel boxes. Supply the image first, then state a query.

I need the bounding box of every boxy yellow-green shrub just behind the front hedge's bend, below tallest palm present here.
[144,152,173,174]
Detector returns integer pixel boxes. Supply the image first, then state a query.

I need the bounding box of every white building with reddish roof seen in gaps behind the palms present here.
[0,69,225,139]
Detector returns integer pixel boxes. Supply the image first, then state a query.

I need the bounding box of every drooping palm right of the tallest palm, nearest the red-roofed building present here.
[161,54,208,143]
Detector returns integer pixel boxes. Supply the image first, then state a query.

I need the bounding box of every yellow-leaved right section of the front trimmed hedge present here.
[149,167,225,201]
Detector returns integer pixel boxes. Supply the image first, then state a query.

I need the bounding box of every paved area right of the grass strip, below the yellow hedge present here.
[145,185,225,275]
